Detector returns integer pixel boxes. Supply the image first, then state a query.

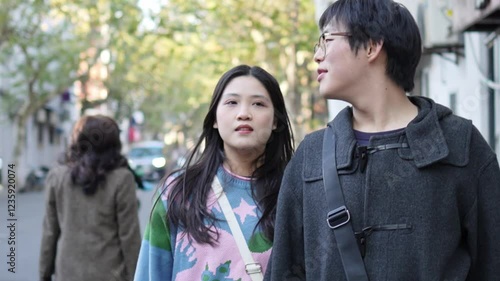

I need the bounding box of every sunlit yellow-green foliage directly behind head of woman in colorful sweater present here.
[141,0,327,140]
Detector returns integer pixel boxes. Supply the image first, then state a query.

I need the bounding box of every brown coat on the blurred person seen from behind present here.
[40,166,141,281]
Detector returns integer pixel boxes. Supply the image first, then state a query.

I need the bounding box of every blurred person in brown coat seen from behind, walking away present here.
[39,115,141,281]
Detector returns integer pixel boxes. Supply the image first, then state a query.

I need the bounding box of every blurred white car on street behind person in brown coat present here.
[127,141,167,182]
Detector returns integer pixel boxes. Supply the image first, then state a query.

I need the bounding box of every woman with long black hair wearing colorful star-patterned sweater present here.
[135,65,293,281]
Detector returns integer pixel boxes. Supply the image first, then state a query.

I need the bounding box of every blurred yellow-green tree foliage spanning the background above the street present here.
[0,0,327,164]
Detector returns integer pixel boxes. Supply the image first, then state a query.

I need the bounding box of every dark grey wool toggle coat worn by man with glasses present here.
[265,97,500,281]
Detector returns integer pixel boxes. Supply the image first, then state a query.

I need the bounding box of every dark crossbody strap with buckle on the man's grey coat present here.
[323,125,368,281]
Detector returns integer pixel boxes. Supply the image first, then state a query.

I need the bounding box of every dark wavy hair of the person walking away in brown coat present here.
[64,115,128,195]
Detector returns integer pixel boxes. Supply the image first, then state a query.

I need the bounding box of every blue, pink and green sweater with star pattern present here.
[134,168,271,281]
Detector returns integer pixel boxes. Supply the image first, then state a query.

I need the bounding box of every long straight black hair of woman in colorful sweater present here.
[155,65,294,245]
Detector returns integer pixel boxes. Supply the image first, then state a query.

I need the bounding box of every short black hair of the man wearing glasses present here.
[319,0,422,92]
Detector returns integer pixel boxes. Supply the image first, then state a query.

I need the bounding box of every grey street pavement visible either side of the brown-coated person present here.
[0,180,154,281]
